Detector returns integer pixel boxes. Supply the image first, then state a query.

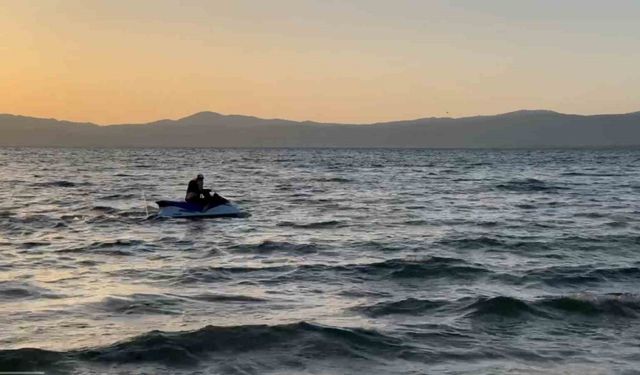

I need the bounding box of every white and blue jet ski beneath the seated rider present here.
[156,193,242,218]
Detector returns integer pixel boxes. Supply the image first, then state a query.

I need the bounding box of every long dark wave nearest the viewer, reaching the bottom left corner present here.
[0,322,415,371]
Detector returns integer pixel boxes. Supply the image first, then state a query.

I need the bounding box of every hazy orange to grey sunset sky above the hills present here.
[0,0,640,123]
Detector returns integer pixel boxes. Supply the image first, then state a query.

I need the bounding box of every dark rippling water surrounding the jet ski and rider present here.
[0,149,640,374]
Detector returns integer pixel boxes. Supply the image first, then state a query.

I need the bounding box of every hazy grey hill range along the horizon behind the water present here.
[0,111,640,148]
